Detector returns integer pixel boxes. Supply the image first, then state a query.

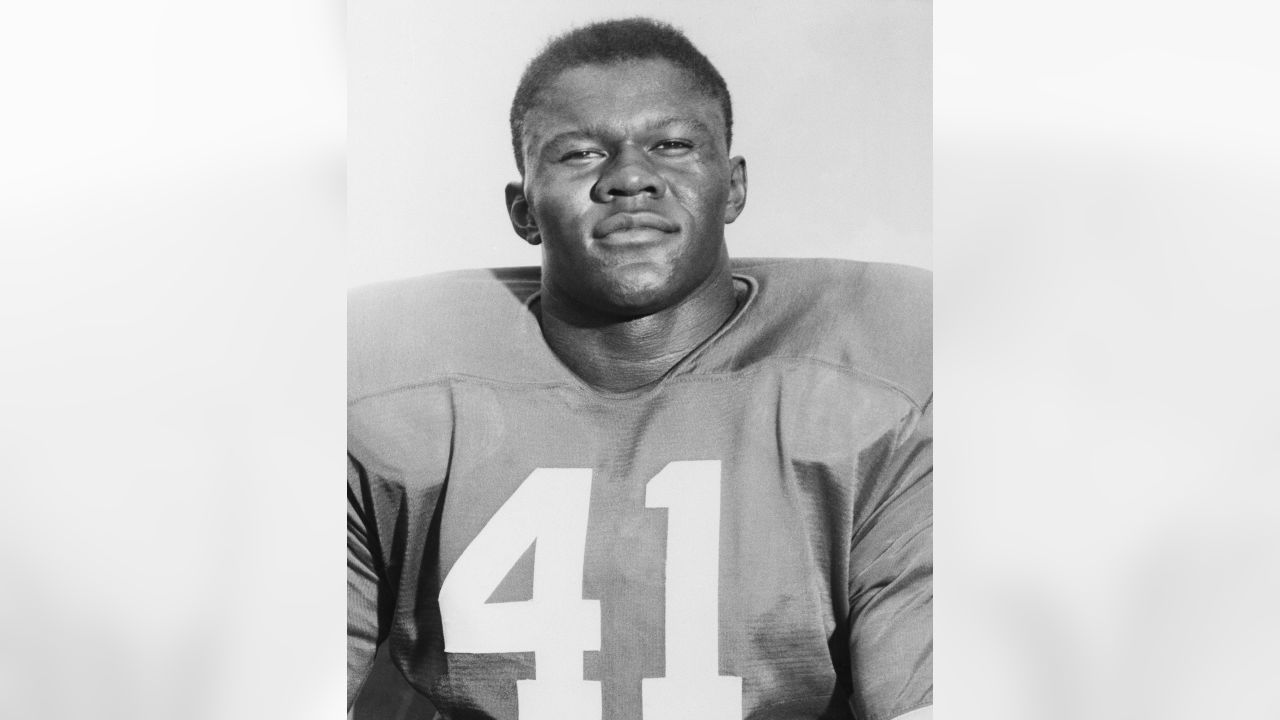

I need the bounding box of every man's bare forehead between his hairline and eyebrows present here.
[525,59,724,142]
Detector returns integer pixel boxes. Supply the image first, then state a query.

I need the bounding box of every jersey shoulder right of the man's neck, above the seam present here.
[735,259,933,406]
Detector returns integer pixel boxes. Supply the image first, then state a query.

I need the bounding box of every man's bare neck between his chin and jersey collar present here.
[541,261,737,392]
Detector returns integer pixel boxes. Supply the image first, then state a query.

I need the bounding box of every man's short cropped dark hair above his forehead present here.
[511,18,733,176]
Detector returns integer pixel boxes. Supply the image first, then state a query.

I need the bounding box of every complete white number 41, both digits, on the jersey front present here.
[440,460,742,720]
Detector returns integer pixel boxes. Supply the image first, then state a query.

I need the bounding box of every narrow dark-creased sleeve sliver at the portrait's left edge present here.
[347,456,385,710]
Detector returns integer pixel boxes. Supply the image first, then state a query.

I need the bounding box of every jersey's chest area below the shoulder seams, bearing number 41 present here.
[412,378,901,720]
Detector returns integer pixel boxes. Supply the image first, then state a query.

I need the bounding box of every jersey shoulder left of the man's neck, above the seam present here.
[347,268,540,400]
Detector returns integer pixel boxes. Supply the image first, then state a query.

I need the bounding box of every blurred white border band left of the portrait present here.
[0,0,346,720]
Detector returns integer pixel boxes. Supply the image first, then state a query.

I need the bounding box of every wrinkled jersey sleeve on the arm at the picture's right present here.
[849,402,933,720]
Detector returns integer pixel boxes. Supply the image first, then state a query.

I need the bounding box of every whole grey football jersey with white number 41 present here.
[348,260,933,720]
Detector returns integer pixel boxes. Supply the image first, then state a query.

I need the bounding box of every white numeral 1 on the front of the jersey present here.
[641,460,742,720]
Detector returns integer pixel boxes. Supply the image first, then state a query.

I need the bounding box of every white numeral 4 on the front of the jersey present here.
[440,468,602,720]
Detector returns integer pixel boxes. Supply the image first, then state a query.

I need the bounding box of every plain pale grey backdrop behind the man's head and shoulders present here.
[347,0,932,284]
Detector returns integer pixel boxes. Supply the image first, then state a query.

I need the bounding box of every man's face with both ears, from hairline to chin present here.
[507,60,746,316]
